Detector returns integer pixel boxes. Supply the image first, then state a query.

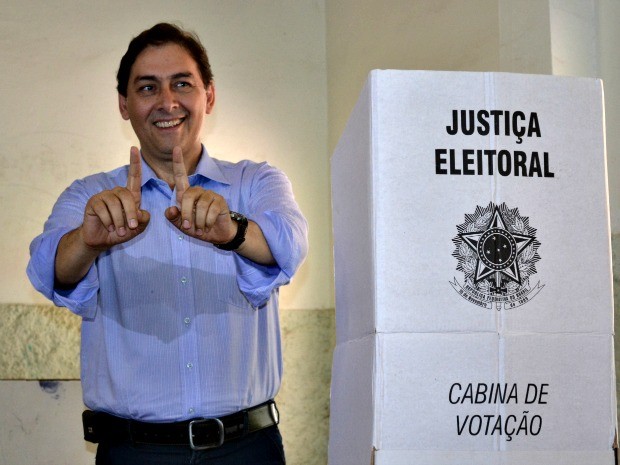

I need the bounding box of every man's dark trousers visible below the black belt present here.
[96,426,286,465]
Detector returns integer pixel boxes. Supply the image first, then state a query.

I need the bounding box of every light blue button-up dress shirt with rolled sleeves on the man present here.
[27,148,307,422]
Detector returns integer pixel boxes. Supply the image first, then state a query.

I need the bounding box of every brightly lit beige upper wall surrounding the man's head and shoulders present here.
[0,0,333,308]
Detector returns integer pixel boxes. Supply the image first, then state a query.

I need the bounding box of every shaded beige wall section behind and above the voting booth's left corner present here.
[325,0,500,153]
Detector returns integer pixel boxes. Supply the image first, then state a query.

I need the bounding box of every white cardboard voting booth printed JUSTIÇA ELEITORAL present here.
[329,71,616,465]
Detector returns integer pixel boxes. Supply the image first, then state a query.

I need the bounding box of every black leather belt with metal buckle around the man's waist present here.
[82,400,279,450]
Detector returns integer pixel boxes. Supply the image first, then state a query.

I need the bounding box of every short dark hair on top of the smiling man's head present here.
[116,23,213,97]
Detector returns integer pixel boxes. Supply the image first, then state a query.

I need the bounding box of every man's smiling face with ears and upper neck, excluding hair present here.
[119,43,215,163]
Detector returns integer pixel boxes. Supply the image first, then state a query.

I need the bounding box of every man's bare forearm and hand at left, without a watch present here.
[55,147,151,287]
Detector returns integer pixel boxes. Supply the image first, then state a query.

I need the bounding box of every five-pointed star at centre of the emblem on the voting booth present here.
[459,207,536,286]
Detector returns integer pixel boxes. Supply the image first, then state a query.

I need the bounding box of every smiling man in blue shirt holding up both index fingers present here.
[28,24,307,465]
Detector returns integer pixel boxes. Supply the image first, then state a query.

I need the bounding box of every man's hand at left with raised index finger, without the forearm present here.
[79,147,150,251]
